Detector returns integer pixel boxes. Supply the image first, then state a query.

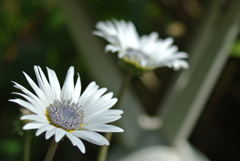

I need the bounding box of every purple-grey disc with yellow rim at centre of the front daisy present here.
[46,100,84,131]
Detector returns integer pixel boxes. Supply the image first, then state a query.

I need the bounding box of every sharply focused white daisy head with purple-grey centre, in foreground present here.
[10,66,123,153]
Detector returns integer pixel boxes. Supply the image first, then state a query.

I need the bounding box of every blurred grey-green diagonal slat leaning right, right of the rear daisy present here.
[158,0,240,145]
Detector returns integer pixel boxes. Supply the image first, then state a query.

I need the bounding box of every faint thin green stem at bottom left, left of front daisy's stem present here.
[23,131,32,161]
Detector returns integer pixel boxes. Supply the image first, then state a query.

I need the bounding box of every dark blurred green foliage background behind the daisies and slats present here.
[0,0,240,161]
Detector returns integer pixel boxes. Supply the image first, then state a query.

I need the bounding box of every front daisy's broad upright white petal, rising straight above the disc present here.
[61,67,74,100]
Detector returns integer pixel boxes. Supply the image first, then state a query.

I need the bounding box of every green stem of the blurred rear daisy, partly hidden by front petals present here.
[97,73,132,161]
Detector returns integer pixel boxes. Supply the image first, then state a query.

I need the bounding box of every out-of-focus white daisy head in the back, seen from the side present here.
[93,20,188,72]
